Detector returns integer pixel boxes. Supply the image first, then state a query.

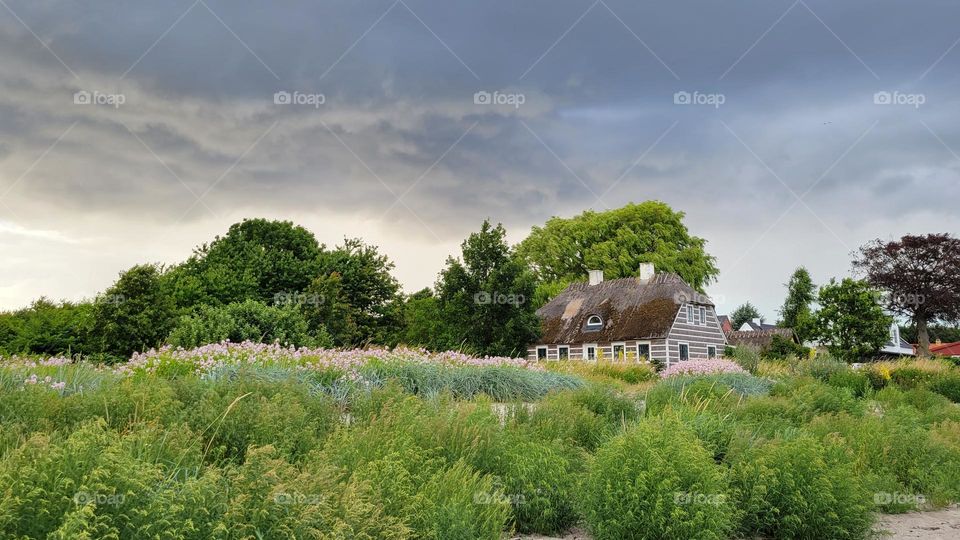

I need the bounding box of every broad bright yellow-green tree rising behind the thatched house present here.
[516,201,720,292]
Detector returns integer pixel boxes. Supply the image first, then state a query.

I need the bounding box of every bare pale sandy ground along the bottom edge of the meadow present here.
[514,506,960,540]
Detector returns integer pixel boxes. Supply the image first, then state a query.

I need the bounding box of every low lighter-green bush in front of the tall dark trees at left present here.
[167,300,316,348]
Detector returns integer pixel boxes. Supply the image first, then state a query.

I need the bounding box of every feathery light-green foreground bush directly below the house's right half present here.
[583,418,734,540]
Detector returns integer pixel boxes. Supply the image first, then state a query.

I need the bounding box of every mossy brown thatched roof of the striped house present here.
[537,273,700,343]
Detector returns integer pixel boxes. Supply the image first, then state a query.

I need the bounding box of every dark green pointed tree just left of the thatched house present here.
[437,220,540,356]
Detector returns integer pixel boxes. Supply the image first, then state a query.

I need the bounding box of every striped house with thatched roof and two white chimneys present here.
[527,263,727,366]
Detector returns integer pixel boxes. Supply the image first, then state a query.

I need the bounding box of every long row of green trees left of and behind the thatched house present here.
[0,201,719,362]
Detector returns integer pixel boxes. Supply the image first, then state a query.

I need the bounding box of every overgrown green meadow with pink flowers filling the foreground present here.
[0,343,960,540]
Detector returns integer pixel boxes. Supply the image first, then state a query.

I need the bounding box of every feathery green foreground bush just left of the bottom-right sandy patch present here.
[731,435,872,539]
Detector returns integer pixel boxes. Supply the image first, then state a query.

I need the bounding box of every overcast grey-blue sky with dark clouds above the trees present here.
[0,0,960,319]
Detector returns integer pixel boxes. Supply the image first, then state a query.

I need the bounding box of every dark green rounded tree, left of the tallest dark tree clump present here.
[93,264,176,360]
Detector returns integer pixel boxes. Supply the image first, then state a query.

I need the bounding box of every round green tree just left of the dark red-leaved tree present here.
[812,278,893,362]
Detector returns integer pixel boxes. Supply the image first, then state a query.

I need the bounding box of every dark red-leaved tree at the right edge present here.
[853,233,960,355]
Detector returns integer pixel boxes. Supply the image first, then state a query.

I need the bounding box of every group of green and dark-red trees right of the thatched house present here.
[731,233,960,361]
